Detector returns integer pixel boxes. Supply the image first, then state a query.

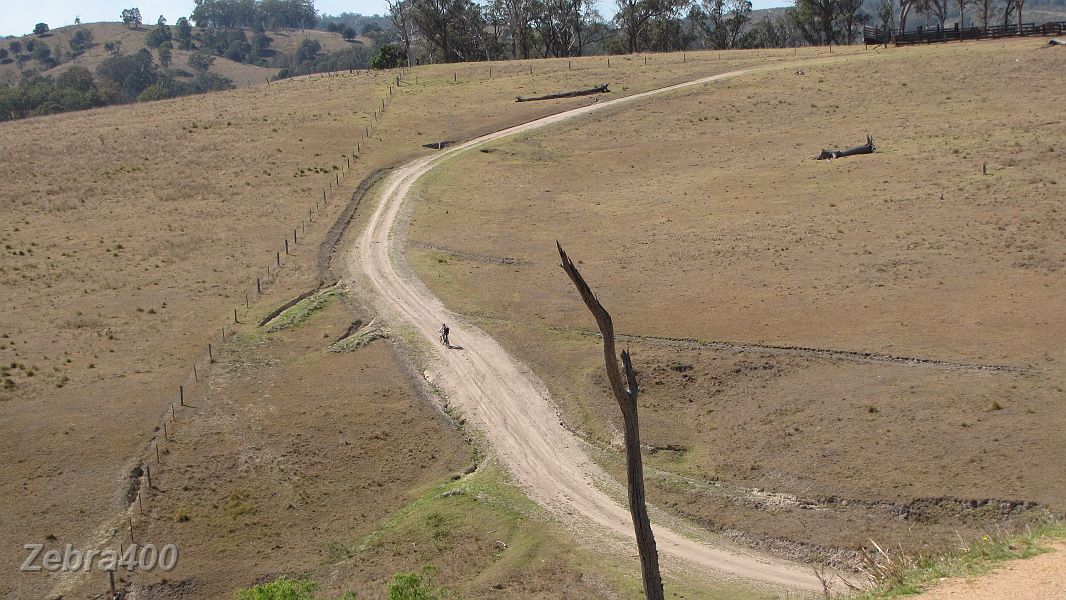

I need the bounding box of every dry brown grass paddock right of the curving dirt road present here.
[408,38,1066,561]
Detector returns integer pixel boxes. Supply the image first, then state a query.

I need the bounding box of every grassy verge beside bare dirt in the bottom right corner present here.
[846,518,1066,600]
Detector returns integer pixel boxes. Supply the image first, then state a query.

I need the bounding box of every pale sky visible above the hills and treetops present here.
[0,0,789,35]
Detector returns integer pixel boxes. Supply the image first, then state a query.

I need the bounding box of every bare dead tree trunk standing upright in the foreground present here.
[555,242,663,600]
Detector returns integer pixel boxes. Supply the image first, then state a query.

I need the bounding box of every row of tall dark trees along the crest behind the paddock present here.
[387,0,1053,62]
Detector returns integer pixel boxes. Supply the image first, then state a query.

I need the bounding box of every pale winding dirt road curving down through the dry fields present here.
[350,71,821,590]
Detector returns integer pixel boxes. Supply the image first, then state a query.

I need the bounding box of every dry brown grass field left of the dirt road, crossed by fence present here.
[0,49,821,598]
